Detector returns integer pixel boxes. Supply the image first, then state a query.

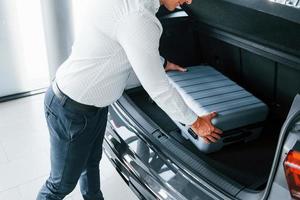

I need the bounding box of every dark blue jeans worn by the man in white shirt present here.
[37,87,108,200]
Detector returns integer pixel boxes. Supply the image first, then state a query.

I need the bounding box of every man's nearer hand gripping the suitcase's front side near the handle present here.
[191,112,223,143]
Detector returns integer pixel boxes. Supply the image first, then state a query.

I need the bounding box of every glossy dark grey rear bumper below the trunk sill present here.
[104,101,224,200]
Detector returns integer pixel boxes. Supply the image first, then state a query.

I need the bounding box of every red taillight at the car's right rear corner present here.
[284,148,300,200]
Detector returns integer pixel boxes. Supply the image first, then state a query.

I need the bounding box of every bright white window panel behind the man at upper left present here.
[0,0,49,97]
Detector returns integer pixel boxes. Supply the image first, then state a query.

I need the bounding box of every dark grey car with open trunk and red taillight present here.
[104,0,300,200]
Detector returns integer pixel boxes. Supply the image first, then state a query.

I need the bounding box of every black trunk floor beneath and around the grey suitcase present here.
[127,87,281,190]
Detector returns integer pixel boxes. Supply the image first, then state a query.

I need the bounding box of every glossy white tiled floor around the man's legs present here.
[0,94,137,200]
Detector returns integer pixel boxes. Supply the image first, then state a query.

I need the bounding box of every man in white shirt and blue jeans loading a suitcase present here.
[37,0,222,200]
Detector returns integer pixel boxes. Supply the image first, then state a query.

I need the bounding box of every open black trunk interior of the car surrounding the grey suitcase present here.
[111,0,300,195]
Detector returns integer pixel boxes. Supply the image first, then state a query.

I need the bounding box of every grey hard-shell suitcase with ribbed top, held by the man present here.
[167,65,268,153]
